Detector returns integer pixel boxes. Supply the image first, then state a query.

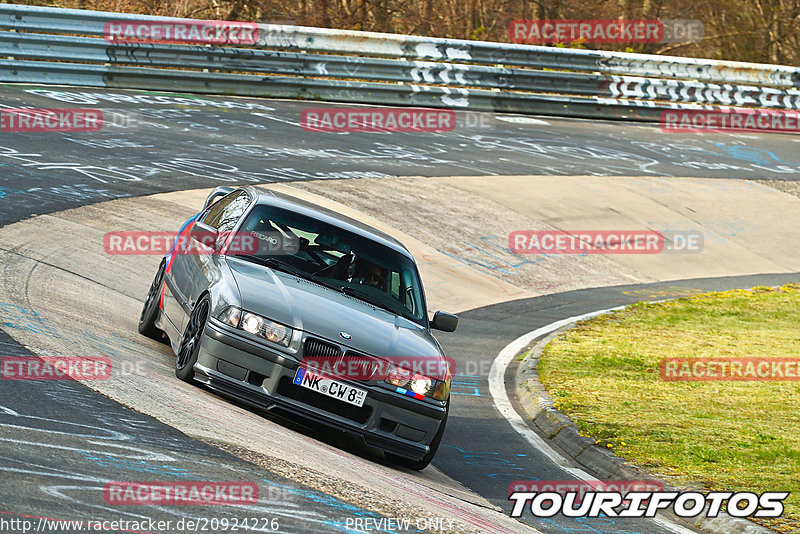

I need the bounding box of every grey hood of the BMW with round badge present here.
[228,258,443,378]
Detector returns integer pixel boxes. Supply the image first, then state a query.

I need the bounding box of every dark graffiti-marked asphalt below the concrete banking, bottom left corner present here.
[0,332,412,533]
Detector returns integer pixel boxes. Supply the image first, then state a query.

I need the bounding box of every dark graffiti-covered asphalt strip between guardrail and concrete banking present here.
[0,84,799,229]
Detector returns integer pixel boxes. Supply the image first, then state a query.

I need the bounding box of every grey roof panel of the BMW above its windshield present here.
[243,186,414,260]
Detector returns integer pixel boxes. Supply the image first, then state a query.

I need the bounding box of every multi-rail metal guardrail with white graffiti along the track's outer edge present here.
[0,4,800,120]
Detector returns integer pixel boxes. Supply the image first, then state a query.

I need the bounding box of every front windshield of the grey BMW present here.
[234,206,426,326]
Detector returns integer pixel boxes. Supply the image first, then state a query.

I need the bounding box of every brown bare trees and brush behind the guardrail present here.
[10,0,800,65]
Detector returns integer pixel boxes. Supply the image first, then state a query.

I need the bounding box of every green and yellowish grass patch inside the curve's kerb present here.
[539,284,800,532]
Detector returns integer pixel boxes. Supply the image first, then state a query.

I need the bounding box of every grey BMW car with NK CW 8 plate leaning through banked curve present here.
[139,187,458,469]
